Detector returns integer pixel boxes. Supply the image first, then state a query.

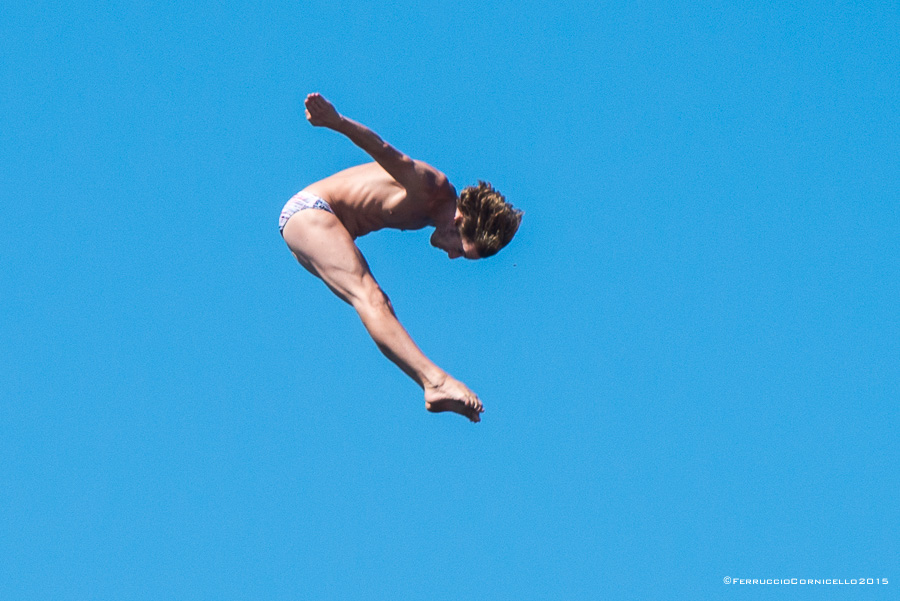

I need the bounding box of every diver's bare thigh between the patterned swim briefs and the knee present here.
[282,209,377,304]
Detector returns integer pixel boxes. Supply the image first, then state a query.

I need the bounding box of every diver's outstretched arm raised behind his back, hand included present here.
[305,94,436,191]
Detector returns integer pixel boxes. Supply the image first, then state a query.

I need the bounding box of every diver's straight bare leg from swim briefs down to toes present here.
[282,209,483,422]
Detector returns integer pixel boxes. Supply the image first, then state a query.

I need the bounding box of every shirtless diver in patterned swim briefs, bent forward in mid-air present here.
[279,94,522,422]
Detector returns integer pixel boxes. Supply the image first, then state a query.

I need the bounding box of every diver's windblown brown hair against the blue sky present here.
[456,181,523,258]
